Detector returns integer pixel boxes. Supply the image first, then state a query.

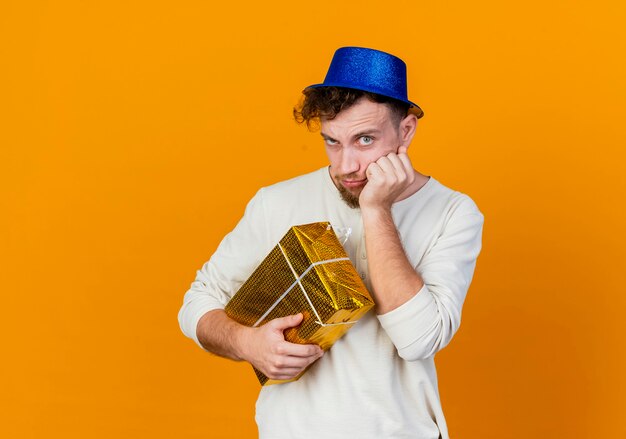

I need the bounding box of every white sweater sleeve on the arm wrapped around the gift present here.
[178,189,267,349]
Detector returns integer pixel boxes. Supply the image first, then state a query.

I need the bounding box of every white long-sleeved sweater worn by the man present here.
[178,168,483,439]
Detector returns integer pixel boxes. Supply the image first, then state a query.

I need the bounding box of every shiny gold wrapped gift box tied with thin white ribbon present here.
[225,222,374,385]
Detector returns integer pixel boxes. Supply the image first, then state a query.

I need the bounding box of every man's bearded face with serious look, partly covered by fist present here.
[321,97,408,208]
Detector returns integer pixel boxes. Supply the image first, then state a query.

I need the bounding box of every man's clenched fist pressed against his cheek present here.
[359,146,415,209]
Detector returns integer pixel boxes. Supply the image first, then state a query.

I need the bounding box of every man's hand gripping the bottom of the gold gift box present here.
[243,314,324,380]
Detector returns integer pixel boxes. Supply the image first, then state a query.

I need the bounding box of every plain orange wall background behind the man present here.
[0,0,626,439]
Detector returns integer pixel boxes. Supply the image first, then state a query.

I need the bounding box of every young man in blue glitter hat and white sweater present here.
[179,47,483,439]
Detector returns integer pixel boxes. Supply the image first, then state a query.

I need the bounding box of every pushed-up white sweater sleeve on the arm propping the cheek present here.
[378,198,483,361]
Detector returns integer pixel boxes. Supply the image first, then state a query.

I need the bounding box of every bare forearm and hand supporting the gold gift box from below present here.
[197,310,324,380]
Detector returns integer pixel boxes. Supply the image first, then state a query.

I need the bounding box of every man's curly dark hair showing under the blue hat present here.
[293,87,423,129]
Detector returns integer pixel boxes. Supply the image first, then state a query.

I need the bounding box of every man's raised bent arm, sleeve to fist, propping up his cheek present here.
[360,148,483,361]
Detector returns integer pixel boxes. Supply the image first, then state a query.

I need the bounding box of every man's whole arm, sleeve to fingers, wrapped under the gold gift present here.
[178,190,322,379]
